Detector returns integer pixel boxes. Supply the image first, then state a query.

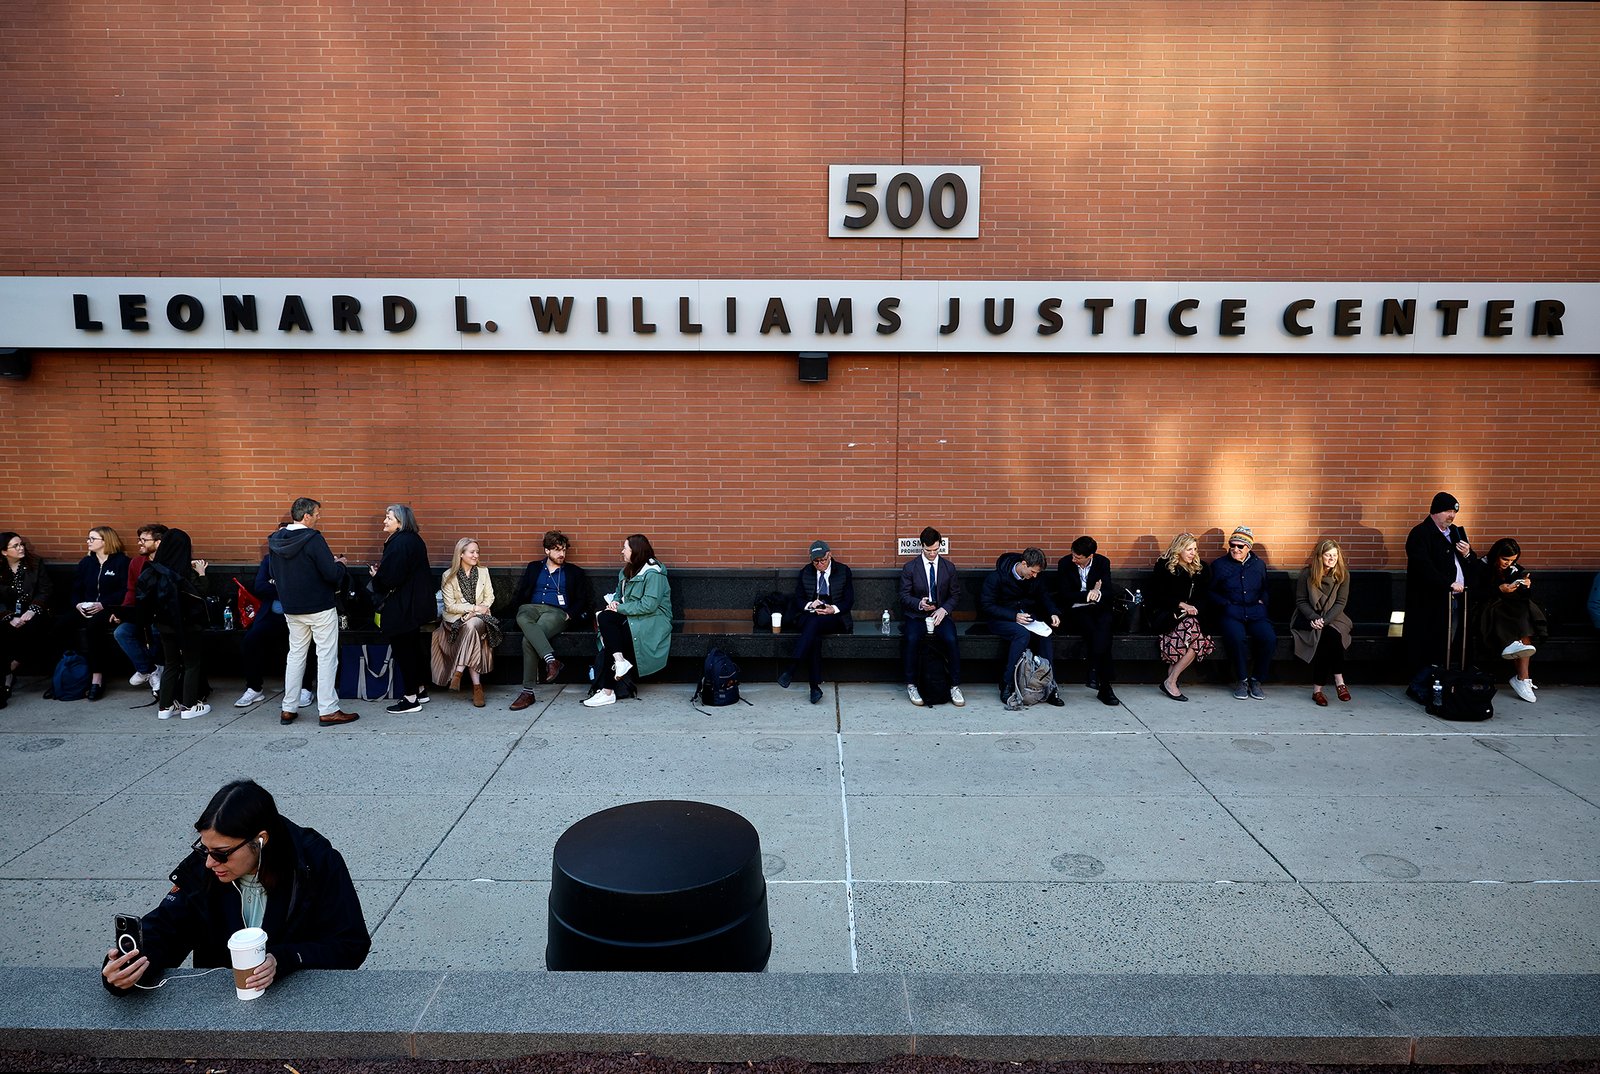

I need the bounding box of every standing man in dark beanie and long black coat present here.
[1405,493,1478,704]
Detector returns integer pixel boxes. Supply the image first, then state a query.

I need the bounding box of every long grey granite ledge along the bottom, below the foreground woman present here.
[0,967,1600,1066]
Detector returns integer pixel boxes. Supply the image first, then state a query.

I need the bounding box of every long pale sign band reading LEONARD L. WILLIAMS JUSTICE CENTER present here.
[0,277,1600,355]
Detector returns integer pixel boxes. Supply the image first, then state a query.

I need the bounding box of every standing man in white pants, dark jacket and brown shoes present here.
[267,496,360,727]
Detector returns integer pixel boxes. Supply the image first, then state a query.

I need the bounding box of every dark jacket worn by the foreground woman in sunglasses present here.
[101,821,373,994]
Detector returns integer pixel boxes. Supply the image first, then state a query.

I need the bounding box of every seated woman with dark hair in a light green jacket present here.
[584,533,672,707]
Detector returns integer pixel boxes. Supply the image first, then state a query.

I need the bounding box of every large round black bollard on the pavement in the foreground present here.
[544,802,773,973]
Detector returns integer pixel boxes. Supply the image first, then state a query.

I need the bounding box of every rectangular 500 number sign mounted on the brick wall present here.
[827,165,981,238]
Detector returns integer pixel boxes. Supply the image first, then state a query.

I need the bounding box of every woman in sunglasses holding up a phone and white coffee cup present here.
[101,779,373,994]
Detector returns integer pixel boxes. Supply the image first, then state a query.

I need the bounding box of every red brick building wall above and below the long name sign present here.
[0,0,1600,567]
